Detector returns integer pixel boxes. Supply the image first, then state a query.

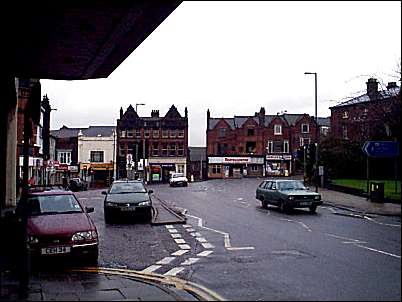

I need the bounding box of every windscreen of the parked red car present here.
[26,195,83,215]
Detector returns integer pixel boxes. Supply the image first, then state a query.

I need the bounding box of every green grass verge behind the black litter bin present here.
[332,179,401,201]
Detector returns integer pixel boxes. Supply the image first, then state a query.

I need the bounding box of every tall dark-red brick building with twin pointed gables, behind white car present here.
[116,105,188,182]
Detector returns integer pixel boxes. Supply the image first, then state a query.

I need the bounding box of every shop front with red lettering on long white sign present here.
[208,156,265,178]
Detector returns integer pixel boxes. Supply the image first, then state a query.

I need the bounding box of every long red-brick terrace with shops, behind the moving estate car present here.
[207,107,326,178]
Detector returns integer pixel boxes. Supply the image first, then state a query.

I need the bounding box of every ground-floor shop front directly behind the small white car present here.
[146,157,187,183]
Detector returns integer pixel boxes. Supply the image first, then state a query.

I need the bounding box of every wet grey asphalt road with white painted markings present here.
[77,179,401,301]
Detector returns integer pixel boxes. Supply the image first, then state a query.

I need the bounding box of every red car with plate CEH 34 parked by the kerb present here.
[16,188,98,264]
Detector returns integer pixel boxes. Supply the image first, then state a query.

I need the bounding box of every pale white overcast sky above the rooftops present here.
[41,1,401,146]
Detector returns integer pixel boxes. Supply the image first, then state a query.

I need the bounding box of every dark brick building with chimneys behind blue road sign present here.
[330,78,401,142]
